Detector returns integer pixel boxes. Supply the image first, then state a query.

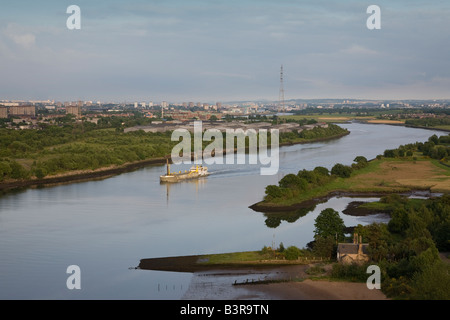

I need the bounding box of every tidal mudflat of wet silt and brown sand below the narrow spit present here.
[176,264,388,300]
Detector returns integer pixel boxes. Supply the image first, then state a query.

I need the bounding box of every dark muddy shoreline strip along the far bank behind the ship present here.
[0,131,350,193]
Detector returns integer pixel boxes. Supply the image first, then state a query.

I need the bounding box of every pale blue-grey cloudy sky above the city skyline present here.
[0,0,450,102]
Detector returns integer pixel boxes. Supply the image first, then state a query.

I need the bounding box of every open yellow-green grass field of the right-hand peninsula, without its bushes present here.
[249,157,450,212]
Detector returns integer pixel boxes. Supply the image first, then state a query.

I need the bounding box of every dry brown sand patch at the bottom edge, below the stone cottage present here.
[243,279,388,300]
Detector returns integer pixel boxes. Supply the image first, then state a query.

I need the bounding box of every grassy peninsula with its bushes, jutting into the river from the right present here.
[251,136,450,211]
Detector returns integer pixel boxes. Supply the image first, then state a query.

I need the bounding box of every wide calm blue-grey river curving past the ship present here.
[0,123,445,300]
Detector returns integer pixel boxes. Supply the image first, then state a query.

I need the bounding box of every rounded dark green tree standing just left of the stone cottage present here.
[314,208,345,240]
